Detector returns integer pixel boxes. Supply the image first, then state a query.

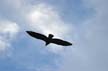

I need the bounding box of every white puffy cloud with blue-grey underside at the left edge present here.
[0,21,19,54]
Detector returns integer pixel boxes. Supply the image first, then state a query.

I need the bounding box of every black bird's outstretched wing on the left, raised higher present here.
[26,31,47,41]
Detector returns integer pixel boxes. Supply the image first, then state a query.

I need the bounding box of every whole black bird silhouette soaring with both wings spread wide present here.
[26,31,72,46]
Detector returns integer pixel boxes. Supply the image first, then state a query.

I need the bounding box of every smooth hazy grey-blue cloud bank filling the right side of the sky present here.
[59,0,108,71]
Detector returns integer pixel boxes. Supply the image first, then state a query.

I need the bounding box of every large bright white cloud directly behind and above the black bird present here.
[27,4,70,52]
